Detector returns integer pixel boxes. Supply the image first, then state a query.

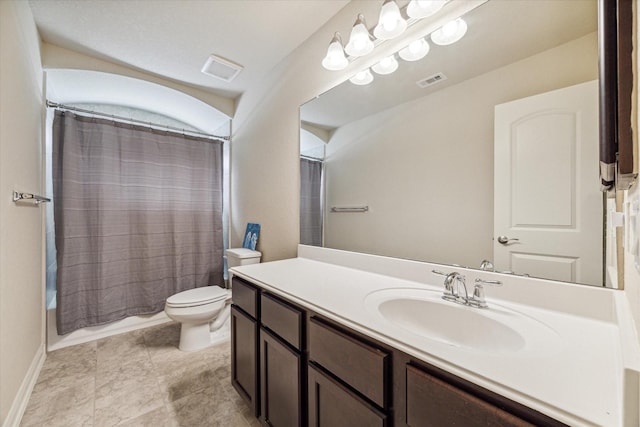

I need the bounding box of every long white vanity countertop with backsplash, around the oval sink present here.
[231,249,640,426]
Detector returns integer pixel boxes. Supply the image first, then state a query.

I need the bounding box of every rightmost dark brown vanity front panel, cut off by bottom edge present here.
[406,365,534,427]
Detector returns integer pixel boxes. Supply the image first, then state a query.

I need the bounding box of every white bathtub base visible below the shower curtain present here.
[47,309,171,351]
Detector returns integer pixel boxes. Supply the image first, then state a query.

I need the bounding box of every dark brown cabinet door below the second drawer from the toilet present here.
[260,328,303,427]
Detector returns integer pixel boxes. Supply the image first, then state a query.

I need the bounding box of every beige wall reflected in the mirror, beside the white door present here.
[324,33,598,266]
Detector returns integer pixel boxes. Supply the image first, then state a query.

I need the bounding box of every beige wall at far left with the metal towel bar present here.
[0,0,44,424]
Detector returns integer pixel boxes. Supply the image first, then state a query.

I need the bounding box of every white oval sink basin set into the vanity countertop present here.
[365,288,560,355]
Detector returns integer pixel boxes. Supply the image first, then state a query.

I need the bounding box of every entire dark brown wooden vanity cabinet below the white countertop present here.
[231,277,564,427]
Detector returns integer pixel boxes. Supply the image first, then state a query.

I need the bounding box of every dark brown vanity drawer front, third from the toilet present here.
[309,317,390,409]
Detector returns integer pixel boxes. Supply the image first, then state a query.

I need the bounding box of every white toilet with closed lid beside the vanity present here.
[164,248,262,351]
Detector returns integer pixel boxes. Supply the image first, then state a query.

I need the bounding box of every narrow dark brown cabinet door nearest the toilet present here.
[231,306,260,416]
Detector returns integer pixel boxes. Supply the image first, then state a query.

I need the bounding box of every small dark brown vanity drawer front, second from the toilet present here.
[260,294,304,350]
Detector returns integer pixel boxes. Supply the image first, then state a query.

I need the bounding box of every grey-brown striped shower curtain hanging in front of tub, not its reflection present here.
[52,111,224,335]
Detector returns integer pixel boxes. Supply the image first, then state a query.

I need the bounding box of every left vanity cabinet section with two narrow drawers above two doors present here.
[231,277,307,427]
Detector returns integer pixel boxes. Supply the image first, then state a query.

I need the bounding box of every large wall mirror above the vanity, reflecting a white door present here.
[300,0,632,286]
